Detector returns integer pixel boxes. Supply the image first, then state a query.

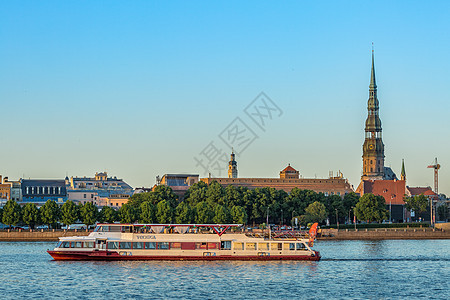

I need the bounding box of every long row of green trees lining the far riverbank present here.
[1,182,426,227]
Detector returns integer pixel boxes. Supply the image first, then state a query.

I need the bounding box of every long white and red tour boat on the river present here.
[47,223,320,261]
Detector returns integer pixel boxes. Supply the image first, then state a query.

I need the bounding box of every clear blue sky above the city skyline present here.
[0,0,450,195]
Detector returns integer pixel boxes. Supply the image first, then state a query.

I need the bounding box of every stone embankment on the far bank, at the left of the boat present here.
[0,230,89,242]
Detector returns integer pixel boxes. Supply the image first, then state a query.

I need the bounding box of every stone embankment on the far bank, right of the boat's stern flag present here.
[318,228,450,240]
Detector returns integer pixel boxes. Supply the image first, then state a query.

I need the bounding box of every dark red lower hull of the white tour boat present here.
[47,250,320,261]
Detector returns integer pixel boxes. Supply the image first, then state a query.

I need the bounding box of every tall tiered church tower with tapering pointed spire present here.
[361,49,384,180]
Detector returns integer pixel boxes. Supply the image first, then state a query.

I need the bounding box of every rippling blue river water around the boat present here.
[0,240,450,299]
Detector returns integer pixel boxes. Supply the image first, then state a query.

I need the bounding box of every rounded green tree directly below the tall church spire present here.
[355,193,387,223]
